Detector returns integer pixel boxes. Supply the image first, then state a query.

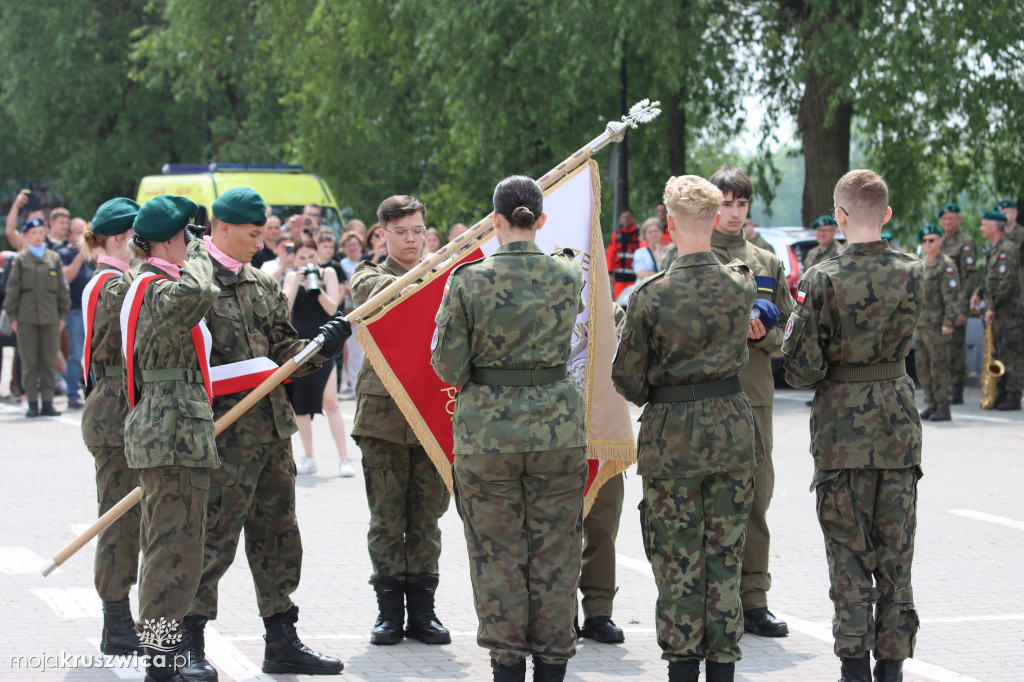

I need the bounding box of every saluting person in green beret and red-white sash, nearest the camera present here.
[121,195,220,682]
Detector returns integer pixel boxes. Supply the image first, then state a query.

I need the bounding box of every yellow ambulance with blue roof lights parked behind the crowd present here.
[135,163,344,235]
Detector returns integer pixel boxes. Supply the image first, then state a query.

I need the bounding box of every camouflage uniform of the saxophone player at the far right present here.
[975,235,1024,401]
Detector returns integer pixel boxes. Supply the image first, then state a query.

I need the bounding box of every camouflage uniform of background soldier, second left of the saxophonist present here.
[913,253,965,408]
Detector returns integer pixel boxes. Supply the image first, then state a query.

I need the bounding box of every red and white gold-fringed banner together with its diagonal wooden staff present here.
[40,99,660,576]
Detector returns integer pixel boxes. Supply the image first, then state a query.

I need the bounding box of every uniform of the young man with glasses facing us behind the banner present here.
[350,257,451,582]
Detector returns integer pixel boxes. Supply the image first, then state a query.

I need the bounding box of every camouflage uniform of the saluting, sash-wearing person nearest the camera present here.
[124,240,220,632]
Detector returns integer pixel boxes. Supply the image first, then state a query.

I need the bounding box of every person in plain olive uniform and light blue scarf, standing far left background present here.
[3,218,71,417]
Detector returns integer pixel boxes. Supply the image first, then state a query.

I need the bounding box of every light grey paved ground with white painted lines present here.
[0,349,1024,682]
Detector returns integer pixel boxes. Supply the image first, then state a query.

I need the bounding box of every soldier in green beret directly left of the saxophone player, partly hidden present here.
[939,204,978,404]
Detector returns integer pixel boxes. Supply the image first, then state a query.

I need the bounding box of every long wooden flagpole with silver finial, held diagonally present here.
[39,99,662,577]
